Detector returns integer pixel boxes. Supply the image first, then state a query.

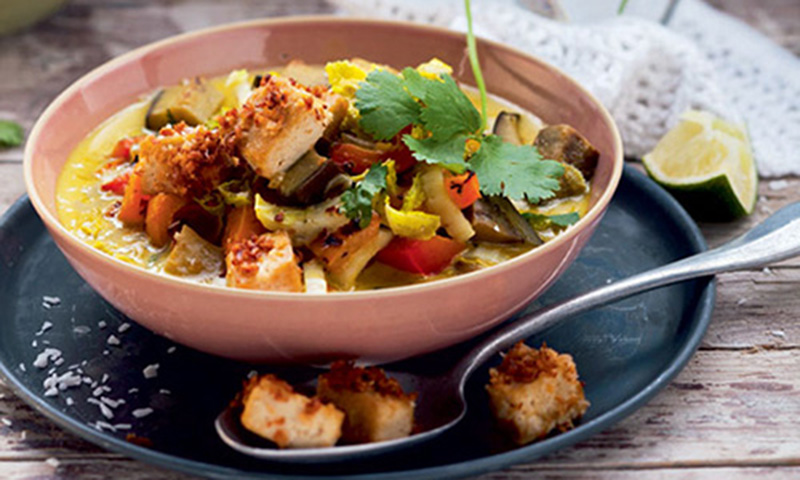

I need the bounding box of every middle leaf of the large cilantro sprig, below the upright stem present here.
[410,74,481,139]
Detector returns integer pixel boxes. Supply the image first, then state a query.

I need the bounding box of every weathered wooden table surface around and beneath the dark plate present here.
[0,0,800,479]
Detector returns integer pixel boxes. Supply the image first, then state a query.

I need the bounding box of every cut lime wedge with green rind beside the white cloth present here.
[642,110,758,221]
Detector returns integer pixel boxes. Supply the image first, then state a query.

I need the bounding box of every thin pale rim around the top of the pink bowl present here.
[23,15,624,302]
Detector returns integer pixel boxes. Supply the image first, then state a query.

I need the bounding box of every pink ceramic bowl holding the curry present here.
[24,18,622,363]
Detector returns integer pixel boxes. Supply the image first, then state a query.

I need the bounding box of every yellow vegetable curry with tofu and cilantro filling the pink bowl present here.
[57,59,598,293]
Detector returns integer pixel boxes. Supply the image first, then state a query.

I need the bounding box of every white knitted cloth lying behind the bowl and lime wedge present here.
[334,0,800,177]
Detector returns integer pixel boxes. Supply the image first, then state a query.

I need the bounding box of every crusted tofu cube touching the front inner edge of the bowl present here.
[225,231,303,292]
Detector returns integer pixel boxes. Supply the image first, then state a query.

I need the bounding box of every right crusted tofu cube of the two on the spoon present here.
[317,361,416,443]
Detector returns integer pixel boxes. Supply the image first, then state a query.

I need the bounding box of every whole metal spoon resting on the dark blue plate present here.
[215,203,800,463]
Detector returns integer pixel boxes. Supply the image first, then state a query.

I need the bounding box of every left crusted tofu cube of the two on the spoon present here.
[240,375,344,448]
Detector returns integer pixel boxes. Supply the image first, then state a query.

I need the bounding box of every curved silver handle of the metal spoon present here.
[451,203,800,387]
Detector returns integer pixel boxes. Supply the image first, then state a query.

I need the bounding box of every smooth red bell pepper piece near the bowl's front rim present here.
[376,235,466,275]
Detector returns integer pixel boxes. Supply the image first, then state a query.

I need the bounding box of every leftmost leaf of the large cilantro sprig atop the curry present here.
[356,70,420,140]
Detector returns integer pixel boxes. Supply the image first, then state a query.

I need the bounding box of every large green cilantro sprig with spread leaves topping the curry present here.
[356,68,564,202]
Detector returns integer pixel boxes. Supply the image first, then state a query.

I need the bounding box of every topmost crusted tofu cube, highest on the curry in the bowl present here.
[238,75,333,182]
